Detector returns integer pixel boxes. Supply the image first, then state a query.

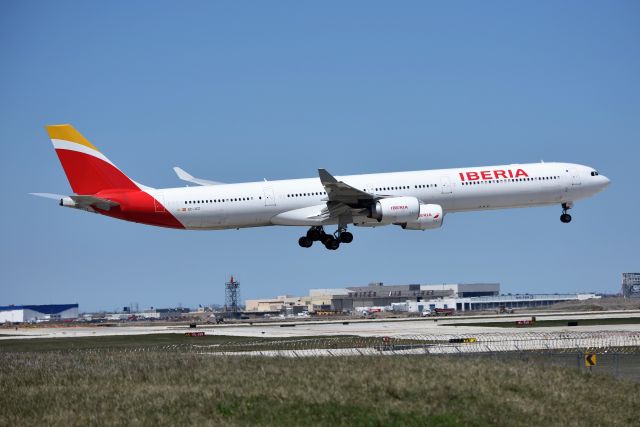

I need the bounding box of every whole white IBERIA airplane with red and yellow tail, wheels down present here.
[31,124,609,250]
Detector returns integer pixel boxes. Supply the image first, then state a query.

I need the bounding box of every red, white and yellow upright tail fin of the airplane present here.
[47,124,139,194]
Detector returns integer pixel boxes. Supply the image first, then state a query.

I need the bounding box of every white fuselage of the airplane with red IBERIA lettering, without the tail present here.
[154,163,609,229]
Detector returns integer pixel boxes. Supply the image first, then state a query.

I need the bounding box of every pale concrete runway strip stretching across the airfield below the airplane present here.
[0,311,640,343]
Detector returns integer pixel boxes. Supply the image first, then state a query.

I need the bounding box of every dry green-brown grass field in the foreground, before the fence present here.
[0,336,640,426]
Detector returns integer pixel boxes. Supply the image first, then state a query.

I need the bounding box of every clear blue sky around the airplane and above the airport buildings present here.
[0,1,640,310]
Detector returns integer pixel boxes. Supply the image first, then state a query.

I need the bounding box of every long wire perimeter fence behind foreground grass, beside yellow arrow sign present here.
[6,330,640,381]
